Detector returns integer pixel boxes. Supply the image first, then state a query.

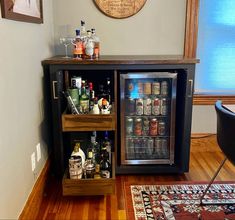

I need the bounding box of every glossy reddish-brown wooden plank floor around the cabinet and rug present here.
[32,136,235,220]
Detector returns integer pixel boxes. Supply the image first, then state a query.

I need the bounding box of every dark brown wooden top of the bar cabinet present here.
[42,55,199,65]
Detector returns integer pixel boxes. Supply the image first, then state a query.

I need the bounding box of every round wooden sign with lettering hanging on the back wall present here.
[94,0,147,18]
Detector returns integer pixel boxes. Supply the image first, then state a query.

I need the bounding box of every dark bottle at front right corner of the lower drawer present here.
[100,147,111,178]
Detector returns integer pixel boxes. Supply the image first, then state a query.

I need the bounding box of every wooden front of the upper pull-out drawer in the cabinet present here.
[62,113,116,131]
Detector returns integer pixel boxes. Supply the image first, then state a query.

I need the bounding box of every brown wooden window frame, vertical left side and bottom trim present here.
[184,0,235,105]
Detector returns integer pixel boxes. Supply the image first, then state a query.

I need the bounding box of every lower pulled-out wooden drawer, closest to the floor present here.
[62,155,115,196]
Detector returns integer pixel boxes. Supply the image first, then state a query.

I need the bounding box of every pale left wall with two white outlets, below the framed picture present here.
[0,1,54,219]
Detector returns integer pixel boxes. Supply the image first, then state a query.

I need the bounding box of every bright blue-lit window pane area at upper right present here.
[195,0,235,95]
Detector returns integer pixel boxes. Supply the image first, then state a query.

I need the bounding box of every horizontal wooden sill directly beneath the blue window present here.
[193,95,235,105]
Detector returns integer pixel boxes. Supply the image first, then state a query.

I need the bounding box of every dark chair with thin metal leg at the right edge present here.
[200,101,235,204]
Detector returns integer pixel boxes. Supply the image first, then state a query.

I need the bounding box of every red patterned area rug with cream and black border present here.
[125,183,235,220]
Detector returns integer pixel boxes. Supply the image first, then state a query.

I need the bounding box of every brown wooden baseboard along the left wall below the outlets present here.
[19,158,51,220]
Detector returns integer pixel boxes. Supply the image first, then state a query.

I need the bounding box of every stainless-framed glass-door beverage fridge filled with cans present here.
[120,72,177,165]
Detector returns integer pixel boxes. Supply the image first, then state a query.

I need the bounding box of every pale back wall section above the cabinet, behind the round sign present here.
[54,0,186,55]
